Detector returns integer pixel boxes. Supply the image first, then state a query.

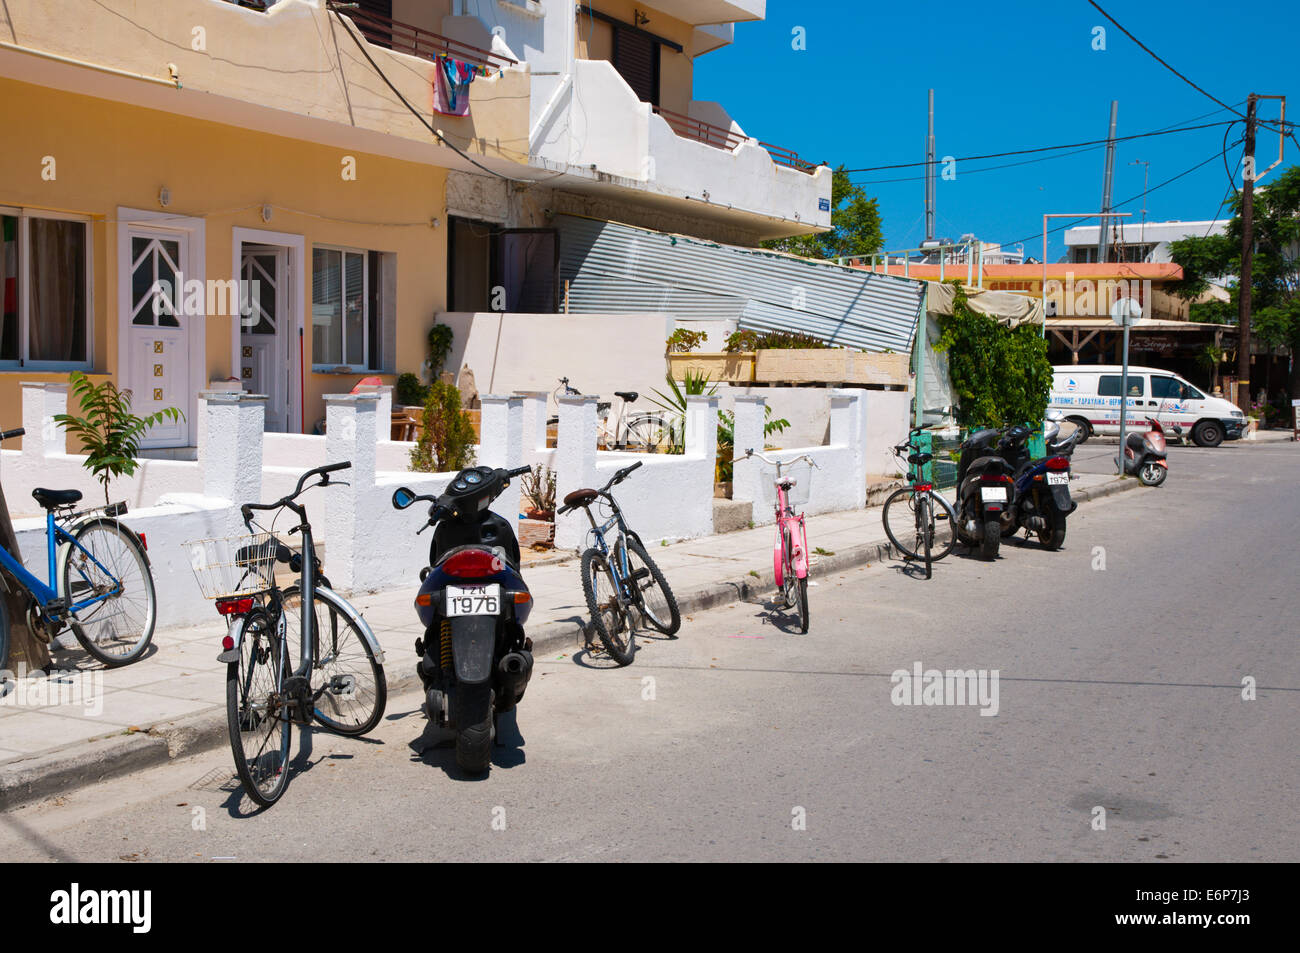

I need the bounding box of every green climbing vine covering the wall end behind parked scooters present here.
[935,282,1052,426]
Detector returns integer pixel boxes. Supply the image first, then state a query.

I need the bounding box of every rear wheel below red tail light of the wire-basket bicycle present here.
[226,610,293,807]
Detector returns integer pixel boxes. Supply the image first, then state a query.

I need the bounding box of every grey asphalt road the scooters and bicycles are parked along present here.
[0,443,1300,863]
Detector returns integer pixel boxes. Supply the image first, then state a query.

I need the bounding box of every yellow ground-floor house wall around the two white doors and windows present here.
[0,79,447,432]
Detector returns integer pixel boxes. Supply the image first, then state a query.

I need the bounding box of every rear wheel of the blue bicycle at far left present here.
[62,519,157,667]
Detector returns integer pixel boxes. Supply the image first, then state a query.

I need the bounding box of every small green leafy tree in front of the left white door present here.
[55,371,185,506]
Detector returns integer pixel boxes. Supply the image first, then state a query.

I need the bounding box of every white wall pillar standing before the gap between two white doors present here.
[199,390,267,506]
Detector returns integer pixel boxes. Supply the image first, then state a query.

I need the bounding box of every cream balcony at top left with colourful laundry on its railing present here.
[0,0,529,172]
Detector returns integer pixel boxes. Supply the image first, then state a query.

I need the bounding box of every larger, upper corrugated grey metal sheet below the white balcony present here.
[555,216,924,352]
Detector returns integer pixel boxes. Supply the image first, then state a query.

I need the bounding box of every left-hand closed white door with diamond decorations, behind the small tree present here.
[124,226,189,447]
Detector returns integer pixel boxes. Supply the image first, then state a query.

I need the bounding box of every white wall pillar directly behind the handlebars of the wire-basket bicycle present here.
[322,393,379,590]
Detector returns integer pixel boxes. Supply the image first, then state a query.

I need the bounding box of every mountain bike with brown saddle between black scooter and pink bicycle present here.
[559,462,681,666]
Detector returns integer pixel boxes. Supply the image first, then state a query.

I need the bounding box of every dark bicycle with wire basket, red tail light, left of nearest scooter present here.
[185,463,387,807]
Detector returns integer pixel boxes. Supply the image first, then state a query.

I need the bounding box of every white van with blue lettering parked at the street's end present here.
[1048,364,1248,447]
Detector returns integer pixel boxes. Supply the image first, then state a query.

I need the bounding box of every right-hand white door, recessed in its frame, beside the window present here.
[239,243,294,433]
